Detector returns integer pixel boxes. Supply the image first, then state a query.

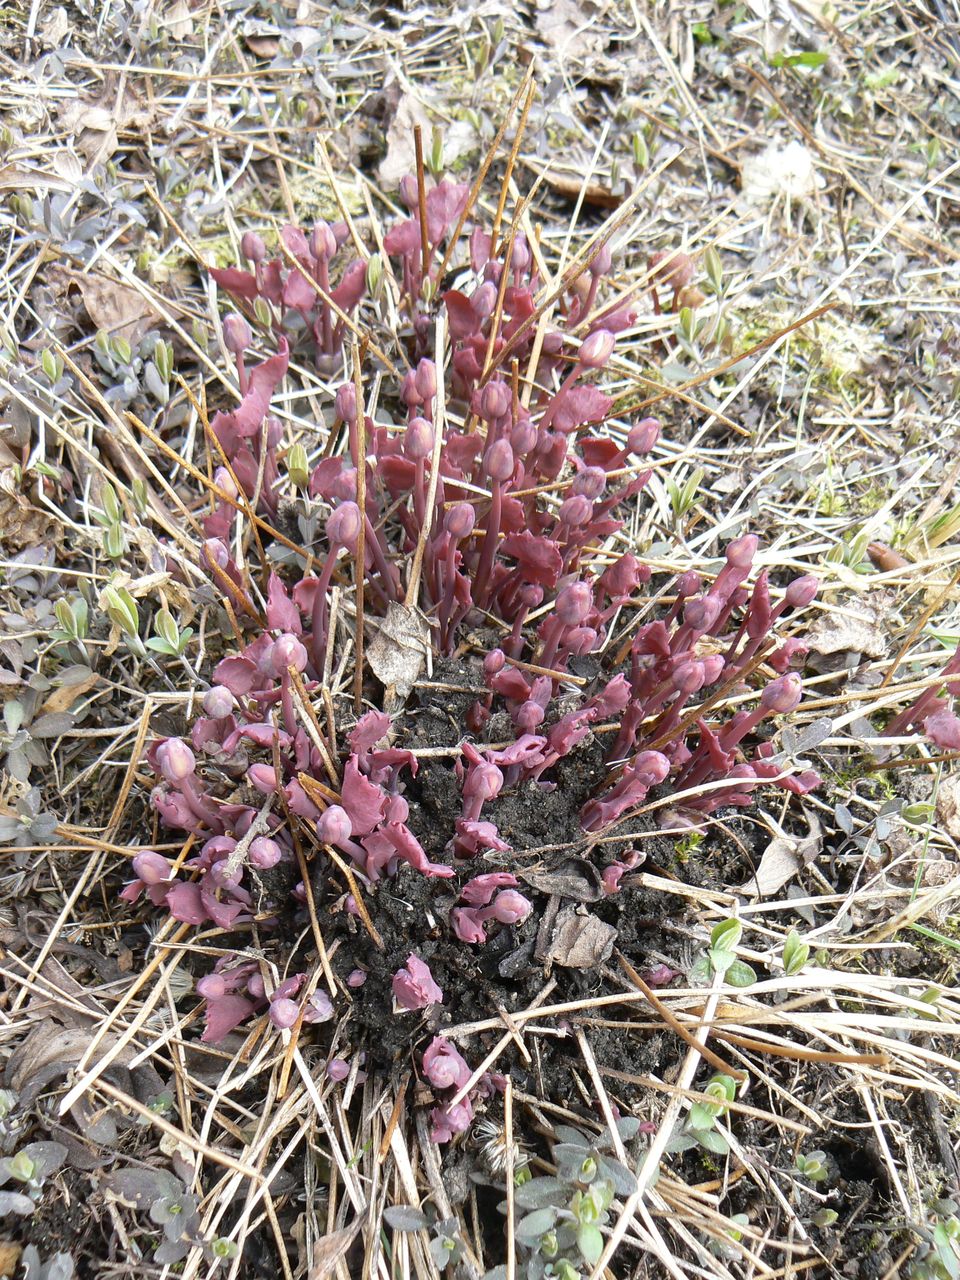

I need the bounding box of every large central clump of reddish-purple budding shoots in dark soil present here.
[120,170,819,1141]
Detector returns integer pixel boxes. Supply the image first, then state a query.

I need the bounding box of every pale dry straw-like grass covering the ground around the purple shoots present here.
[0,0,960,1280]
